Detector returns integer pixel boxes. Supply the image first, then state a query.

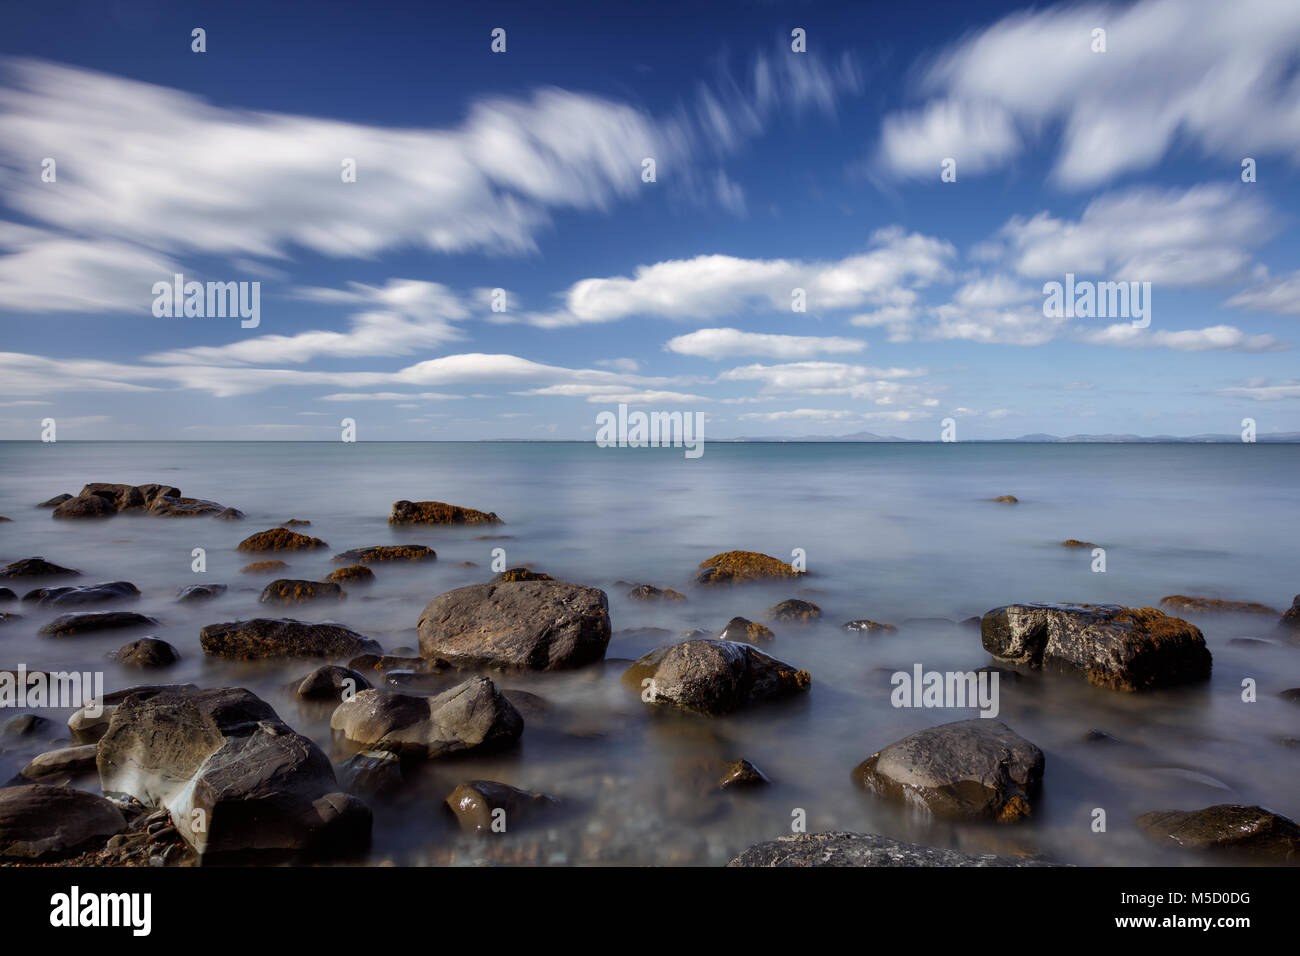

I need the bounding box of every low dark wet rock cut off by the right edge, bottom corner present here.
[1138,804,1300,862]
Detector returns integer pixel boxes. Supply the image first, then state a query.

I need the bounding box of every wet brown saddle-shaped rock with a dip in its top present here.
[329,678,524,760]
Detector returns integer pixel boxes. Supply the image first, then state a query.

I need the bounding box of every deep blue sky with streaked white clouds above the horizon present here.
[0,0,1300,441]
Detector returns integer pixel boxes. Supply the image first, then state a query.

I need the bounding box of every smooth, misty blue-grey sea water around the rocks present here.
[0,441,1300,865]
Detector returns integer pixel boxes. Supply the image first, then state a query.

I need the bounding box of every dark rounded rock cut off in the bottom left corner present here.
[0,783,126,860]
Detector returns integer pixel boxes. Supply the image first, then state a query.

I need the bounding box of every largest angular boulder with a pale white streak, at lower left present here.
[99,687,371,857]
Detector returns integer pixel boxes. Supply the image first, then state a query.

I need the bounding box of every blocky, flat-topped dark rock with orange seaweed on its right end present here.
[980,604,1212,691]
